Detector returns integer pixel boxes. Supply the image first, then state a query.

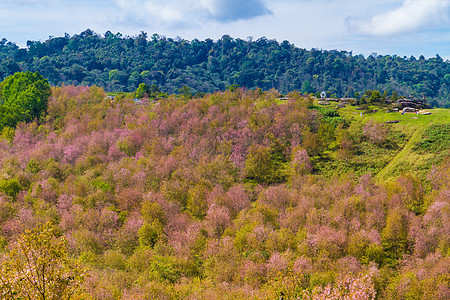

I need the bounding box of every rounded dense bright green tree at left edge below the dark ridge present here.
[0,72,51,128]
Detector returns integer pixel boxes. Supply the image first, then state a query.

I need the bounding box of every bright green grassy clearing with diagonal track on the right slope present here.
[314,105,450,181]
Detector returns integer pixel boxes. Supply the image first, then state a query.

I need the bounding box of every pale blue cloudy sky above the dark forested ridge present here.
[0,0,450,59]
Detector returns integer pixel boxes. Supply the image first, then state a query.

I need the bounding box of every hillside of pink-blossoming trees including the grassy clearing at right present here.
[0,85,450,299]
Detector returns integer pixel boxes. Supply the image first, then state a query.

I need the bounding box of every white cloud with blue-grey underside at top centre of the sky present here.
[116,0,271,27]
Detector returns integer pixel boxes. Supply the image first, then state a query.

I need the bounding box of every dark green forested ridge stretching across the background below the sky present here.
[0,30,450,107]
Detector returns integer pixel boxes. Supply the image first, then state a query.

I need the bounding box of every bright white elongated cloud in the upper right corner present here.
[348,0,450,36]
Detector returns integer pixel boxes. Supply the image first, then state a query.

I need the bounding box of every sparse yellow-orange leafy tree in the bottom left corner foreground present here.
[0,223,86,300]
